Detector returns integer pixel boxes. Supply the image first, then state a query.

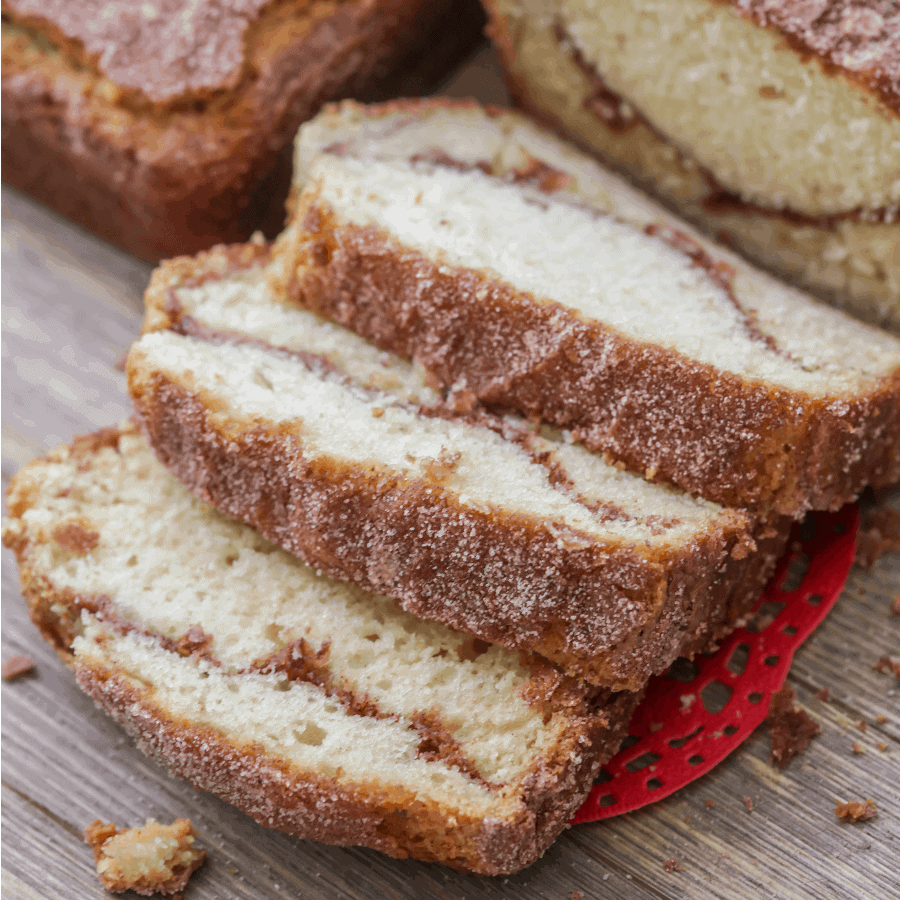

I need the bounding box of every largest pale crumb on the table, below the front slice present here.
[84,819,206,897]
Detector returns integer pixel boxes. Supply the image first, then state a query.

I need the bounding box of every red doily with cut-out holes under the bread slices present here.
[572,506,859,824]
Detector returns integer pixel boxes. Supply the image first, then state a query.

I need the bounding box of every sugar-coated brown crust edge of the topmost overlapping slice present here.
[279,207,900,517]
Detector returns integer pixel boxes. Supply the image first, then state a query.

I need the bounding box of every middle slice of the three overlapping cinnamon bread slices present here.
[127,244,784,690]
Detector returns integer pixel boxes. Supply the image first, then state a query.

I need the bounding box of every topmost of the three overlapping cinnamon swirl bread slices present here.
[274,100,900,516]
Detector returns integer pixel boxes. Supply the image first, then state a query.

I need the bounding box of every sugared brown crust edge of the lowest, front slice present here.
[75,662,638,875]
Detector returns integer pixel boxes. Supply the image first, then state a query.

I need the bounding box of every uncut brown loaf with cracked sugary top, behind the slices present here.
[0,0,483,262]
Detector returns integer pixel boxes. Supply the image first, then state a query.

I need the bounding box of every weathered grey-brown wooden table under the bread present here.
[2,52,900,900]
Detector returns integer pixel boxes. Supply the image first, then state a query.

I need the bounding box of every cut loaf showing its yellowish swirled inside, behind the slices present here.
[485,0,900,331]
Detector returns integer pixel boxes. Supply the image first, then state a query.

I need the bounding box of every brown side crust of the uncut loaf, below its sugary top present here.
[0,0,482,262]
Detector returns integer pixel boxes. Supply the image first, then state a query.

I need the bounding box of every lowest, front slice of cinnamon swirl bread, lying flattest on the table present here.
[3,425,638,874]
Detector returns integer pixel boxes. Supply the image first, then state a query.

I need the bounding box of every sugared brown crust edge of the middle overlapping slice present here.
[128,248,787,690]
